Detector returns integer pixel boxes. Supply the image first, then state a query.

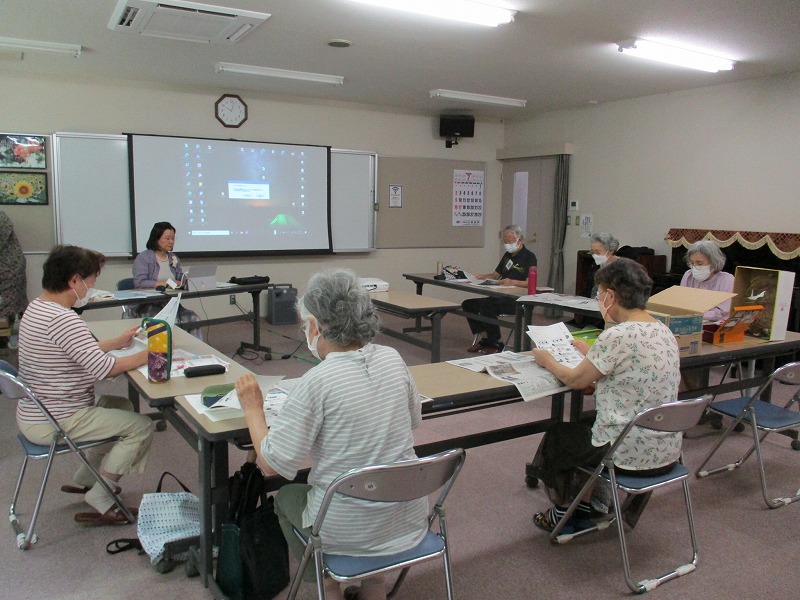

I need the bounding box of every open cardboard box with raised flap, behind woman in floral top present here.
[647,285,736,356]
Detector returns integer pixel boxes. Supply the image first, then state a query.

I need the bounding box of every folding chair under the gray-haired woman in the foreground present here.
[287,448,466,600]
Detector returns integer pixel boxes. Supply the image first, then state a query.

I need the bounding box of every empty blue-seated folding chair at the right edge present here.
[695,362,800,508]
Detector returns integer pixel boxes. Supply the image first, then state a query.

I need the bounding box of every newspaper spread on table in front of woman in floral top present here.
[447,352,569,402]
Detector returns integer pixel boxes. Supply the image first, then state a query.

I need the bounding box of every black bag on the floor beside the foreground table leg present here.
[217,453,289,600]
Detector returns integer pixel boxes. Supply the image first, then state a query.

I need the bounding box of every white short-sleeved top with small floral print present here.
[586,321,682,470]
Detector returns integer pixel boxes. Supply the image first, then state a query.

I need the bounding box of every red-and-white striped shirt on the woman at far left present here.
[17,298,114,422]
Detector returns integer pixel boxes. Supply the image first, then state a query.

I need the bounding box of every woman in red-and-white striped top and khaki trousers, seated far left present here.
[17,246,153,525]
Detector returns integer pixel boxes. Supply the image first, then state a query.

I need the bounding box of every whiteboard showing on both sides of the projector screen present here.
[53,133,377,256]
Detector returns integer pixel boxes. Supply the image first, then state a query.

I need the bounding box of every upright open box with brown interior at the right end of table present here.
[733,267,794,340]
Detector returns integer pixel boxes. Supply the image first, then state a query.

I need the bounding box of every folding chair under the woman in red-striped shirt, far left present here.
[0,360,136,550]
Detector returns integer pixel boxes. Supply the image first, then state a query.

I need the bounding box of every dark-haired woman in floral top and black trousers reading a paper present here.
[533,258,681,533]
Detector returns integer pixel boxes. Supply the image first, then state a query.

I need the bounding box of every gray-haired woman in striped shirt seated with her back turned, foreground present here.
[236,270,428,600]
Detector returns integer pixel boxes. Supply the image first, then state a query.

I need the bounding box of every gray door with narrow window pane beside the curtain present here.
[500,156,557,286]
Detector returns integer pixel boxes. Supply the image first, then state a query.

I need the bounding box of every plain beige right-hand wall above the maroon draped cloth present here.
[505,74,800,290]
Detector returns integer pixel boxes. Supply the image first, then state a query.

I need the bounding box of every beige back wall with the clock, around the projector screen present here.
[0,75,503,317]
